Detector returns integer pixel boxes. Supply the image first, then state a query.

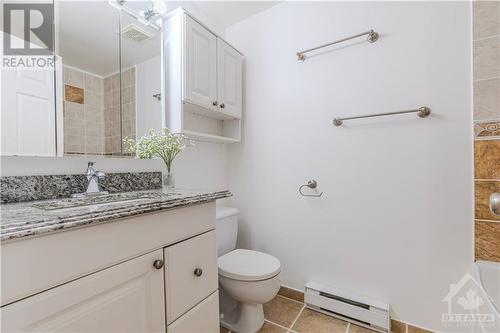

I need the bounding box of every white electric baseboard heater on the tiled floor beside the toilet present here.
[304,282,391,332]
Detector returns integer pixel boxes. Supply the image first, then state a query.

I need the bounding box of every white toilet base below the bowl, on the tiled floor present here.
[221,303,264,333]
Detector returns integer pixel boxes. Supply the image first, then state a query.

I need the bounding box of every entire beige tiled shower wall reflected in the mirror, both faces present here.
[63,66,136,155]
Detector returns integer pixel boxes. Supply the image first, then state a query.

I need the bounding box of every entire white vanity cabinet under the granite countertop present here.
[0,202,219,333]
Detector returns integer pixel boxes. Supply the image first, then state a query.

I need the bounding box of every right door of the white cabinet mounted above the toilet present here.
[217,39,243,117]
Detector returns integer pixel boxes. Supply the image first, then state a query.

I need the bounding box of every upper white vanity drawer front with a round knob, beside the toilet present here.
[164,231,218,324]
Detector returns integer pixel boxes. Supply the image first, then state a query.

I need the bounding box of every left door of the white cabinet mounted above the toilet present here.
[184,16,217,110]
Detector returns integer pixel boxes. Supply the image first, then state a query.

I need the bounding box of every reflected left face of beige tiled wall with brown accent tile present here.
[63,66,104,155]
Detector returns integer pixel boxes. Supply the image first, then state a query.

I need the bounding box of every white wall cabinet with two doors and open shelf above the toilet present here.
[163,8,243,143]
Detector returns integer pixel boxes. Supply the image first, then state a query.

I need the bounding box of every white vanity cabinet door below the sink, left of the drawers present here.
[1,250,166,332]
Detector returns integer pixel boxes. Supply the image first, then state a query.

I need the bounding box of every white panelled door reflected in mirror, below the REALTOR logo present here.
[0,69,56,156]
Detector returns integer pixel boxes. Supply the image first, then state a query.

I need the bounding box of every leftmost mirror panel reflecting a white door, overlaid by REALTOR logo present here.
[0,1,59,156]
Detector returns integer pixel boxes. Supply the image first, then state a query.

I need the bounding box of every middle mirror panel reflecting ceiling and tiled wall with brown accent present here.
[57,1,121,155]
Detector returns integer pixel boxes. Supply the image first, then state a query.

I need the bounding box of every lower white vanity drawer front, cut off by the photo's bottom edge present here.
[167,292,219,333]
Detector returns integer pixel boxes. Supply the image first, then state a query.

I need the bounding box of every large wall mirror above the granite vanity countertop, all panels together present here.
[2,0,164,157]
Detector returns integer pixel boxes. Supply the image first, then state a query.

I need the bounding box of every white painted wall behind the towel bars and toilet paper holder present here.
[226,1,473,330]
